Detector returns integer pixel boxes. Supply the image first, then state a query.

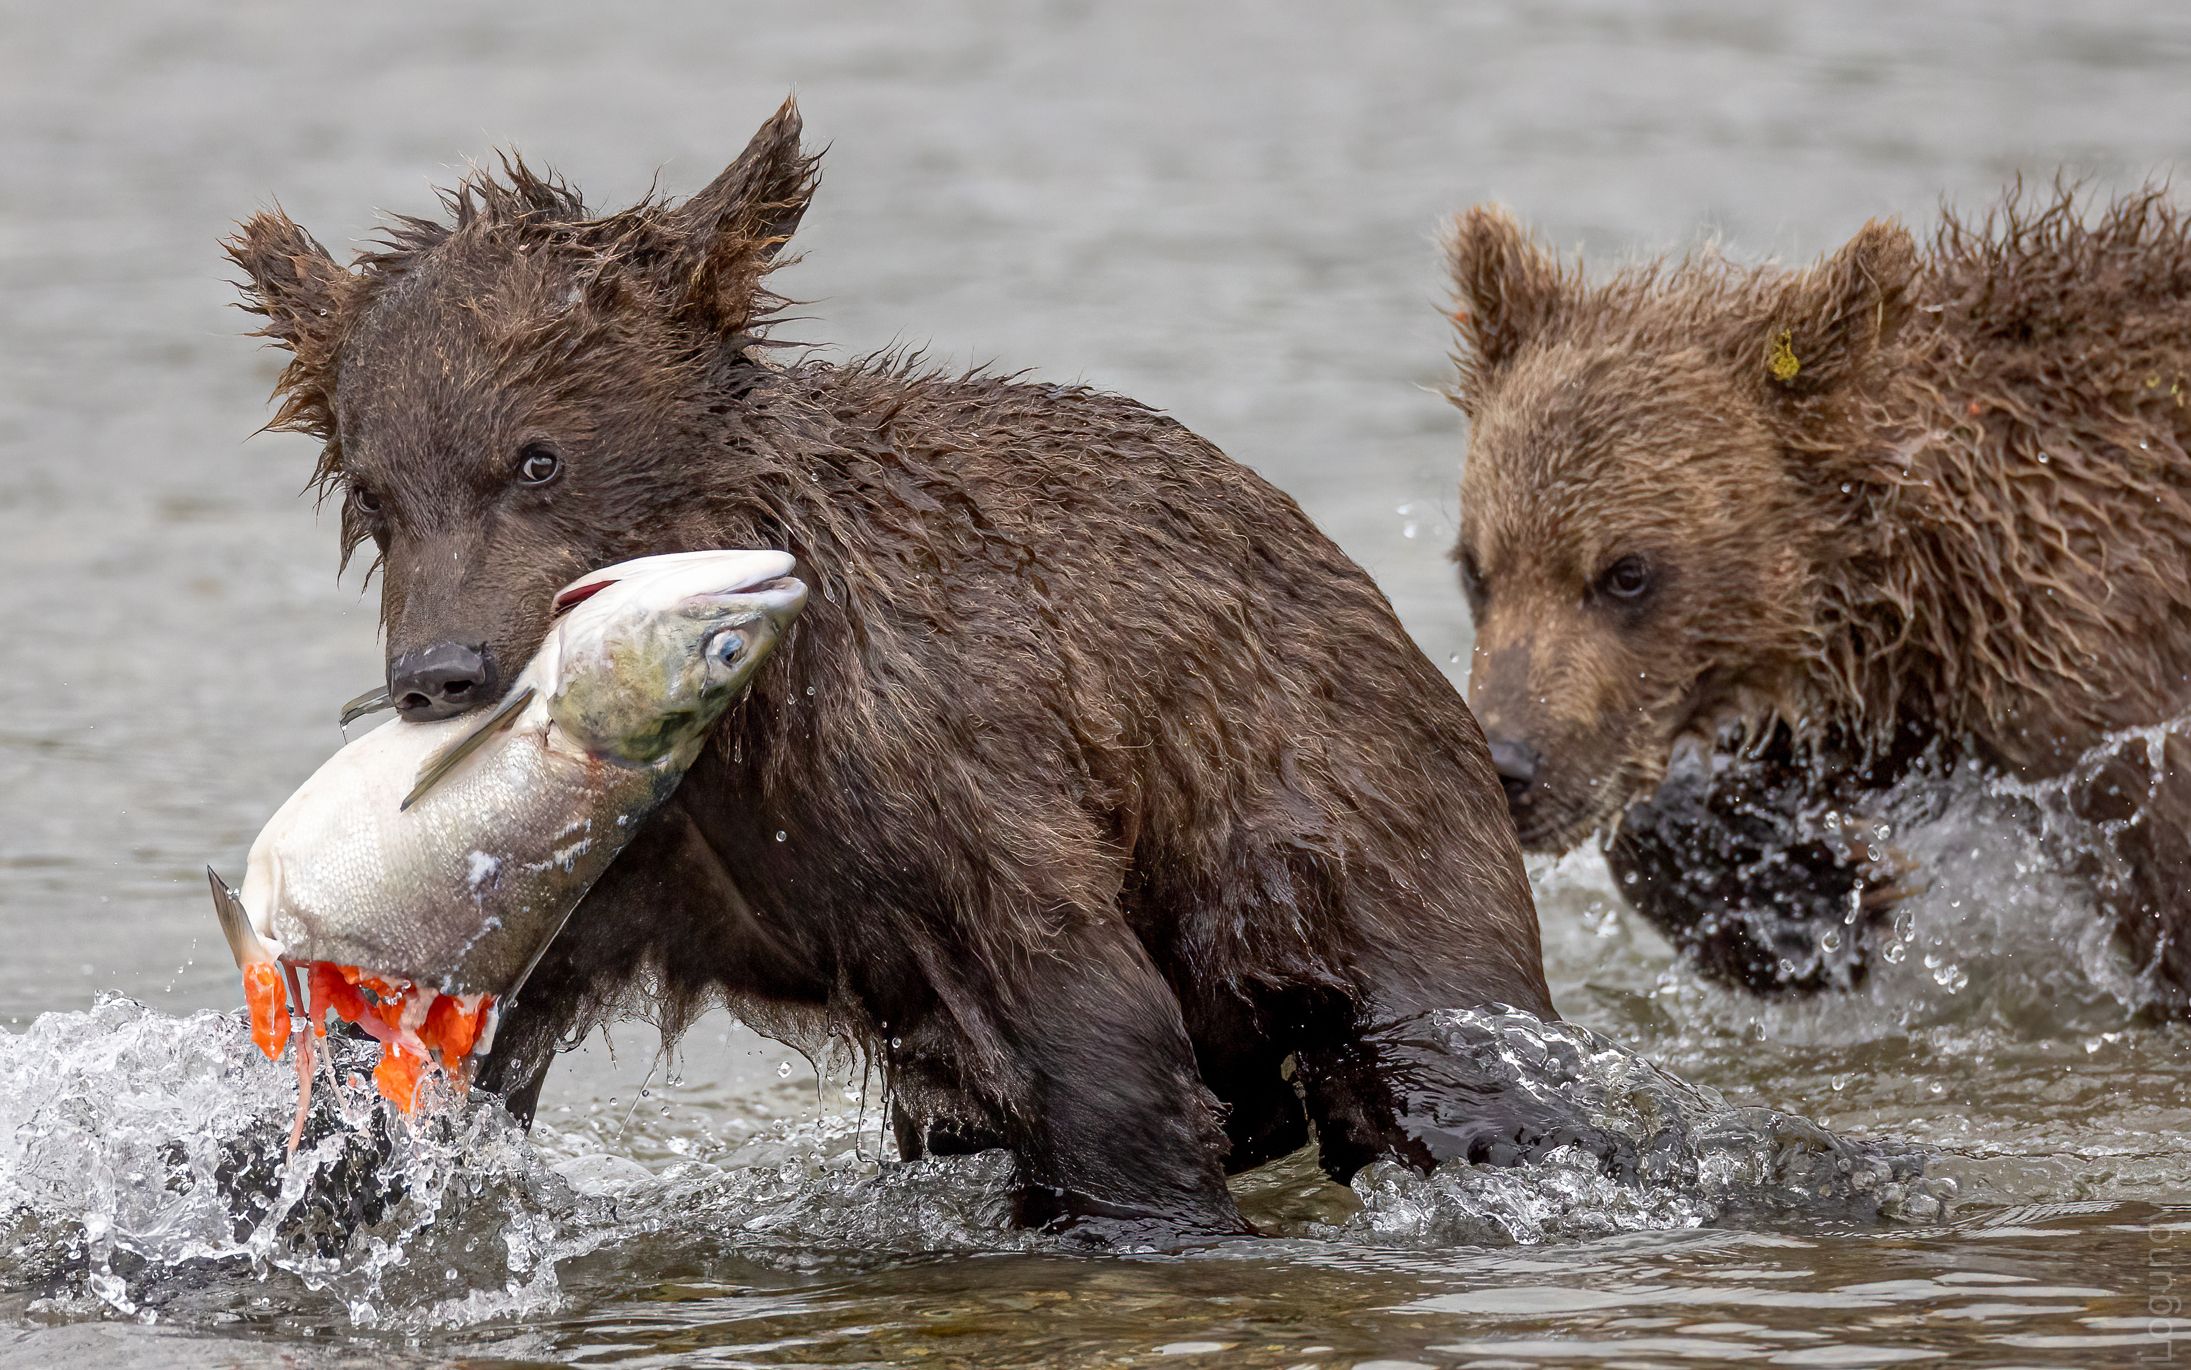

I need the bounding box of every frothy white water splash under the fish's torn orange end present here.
[0,997,581,1326]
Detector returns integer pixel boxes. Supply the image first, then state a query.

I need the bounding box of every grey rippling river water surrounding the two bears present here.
[0,0,2191,1366]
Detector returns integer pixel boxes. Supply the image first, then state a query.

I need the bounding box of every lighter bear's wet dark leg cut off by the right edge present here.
[2075,734,2191,1017]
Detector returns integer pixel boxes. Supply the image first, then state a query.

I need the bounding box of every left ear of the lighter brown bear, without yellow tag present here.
[1446,204,1569,414]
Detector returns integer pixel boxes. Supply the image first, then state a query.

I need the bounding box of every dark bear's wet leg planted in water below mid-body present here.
[993,918,1251,1243]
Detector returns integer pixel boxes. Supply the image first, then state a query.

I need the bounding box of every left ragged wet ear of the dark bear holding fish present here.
[221,208,357,438]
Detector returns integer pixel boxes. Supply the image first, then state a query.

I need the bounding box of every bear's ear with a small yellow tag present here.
[1742,219,1917,397]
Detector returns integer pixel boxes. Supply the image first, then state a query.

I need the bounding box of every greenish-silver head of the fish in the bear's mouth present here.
[541,550,806,765]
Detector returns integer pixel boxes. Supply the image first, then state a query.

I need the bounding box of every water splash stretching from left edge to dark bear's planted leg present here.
[0,997,1025,1331]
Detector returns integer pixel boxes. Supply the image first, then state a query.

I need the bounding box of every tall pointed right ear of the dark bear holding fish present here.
[670,99,822,338]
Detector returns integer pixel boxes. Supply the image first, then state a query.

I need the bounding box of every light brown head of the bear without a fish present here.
[1446,208,1917,850]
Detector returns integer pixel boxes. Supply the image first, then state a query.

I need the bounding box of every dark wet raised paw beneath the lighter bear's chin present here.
[1606,732,1906,993]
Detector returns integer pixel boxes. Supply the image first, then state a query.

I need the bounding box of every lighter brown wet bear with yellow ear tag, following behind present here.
[1448,191,2191,1008]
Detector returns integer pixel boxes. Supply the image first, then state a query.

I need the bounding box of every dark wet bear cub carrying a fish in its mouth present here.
[230,103,1551,1232]
